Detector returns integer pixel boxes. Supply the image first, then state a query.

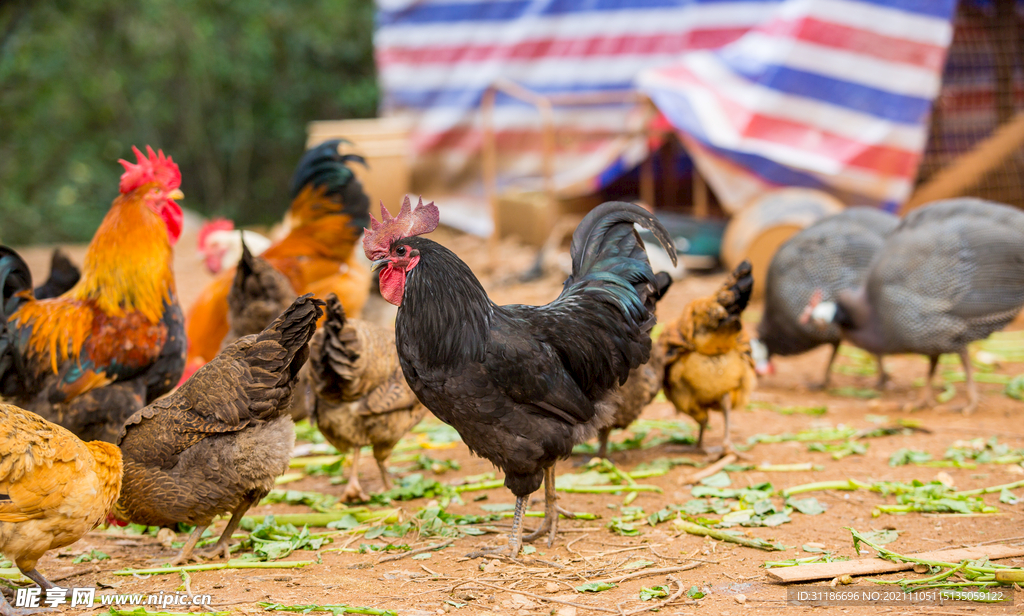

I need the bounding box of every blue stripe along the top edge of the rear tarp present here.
[377,0,781,27]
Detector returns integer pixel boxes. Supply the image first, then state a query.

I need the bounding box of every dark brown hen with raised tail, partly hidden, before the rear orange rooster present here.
[220,241,298,349]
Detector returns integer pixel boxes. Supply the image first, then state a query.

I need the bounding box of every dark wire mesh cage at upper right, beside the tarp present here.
[918,0,1024,207]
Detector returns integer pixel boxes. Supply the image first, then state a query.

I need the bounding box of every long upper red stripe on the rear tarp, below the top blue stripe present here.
[377,28,749,68]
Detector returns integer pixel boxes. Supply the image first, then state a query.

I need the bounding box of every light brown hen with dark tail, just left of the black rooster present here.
[308,294,427,500]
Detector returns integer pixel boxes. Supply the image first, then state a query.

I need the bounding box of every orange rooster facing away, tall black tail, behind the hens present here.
[185,139,370,378]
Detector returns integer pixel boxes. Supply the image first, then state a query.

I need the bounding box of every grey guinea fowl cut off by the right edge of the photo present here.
[805,199,1024,413]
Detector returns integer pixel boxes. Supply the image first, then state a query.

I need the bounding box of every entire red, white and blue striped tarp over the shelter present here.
[375,0,954,217]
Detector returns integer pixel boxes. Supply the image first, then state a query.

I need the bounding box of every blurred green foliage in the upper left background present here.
[0,0,378,245]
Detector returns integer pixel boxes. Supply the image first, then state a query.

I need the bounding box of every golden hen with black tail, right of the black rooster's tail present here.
[658,261,757,448]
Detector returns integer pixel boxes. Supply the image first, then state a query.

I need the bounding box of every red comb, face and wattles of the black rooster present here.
[362,196,439,306]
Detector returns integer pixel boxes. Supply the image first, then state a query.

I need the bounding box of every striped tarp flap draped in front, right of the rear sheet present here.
[639,0,955,209]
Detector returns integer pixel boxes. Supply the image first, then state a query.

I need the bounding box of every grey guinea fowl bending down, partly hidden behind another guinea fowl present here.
[751,208,899,389]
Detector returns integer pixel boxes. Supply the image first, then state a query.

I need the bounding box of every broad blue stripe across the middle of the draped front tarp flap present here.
[716,53,932,126]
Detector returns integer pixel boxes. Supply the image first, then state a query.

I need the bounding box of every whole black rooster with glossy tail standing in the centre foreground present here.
[362,199,676,558]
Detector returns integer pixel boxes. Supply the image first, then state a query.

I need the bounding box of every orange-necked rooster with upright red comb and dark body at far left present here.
[0,147,185,441]
